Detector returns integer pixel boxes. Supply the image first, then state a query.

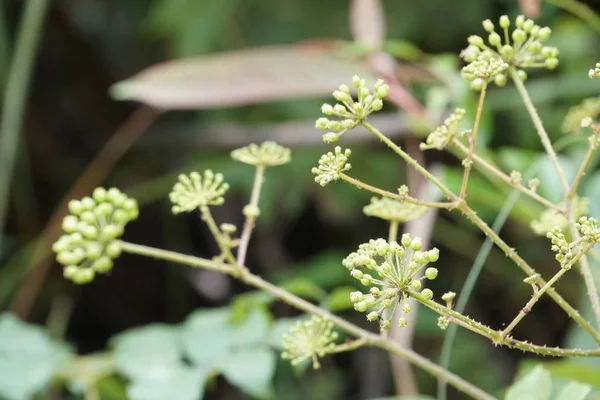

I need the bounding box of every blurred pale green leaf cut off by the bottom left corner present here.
[0,313,70,400]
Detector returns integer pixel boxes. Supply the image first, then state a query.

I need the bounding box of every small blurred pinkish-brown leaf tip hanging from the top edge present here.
[350,0,385,47]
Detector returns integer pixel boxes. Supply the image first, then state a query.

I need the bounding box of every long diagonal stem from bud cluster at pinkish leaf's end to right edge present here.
[356,121,600,344]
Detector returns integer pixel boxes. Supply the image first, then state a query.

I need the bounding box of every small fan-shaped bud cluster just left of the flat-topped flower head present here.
[169,170,229,214]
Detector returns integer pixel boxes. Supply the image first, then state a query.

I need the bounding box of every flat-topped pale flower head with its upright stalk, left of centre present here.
[231,142,291,268]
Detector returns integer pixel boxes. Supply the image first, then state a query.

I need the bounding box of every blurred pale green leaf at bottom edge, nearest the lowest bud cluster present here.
[221,347,277,398]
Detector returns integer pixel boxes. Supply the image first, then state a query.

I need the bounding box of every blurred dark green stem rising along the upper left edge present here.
[0,0,49,251]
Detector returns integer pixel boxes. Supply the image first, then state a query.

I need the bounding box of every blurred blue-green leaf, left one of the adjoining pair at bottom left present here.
[112,324,182,381]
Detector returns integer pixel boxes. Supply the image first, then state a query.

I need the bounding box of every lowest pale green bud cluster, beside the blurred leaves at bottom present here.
[281,316,338,369]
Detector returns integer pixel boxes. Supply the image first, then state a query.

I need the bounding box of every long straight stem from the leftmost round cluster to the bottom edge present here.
[119,241,495,400]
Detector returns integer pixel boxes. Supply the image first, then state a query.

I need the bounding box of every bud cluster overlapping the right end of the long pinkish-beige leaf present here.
[315,75,390,143]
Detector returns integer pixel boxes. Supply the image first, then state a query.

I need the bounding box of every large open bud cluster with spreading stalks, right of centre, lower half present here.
[342,234,439,330]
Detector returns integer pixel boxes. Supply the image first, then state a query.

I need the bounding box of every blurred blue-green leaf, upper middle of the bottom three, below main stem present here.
[183,308,234,368]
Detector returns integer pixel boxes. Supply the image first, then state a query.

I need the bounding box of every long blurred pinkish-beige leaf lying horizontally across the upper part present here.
[111,46,372,110]
